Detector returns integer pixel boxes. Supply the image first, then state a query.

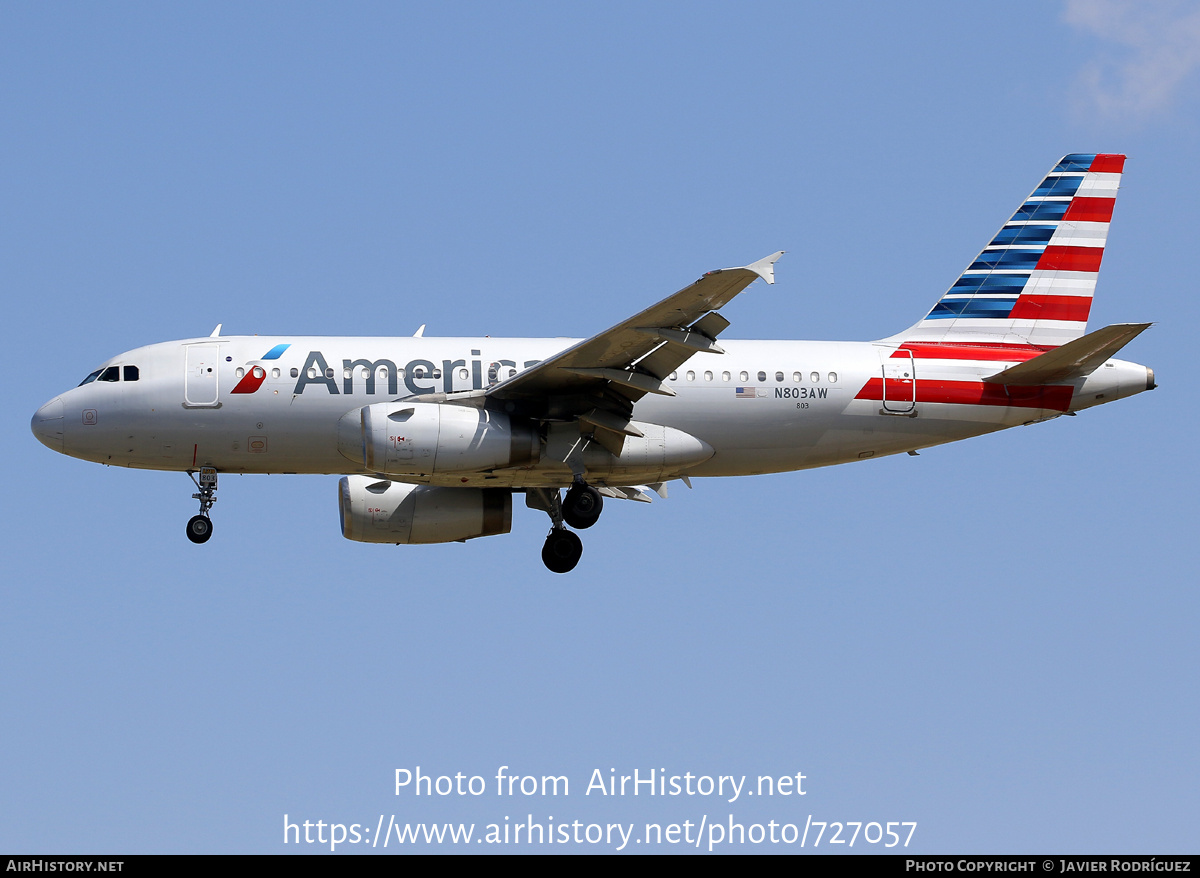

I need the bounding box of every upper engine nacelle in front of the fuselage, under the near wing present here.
[337,402,541,475]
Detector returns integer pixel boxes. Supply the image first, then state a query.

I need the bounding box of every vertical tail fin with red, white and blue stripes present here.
[896,154,1126,348]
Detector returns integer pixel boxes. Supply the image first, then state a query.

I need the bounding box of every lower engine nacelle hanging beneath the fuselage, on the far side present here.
[337,475,512,543]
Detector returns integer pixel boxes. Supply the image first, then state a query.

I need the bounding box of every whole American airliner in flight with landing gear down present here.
[31,154,1156,573]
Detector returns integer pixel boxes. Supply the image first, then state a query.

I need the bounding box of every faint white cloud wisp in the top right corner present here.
[1063,0,1200,119]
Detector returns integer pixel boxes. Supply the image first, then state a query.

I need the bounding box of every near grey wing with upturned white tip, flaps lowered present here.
[486,251,784,453]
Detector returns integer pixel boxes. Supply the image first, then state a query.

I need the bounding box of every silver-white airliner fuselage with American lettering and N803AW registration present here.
[32,336,1153,488]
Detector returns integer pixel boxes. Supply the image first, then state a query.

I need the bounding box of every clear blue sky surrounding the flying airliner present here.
[0,0,1200,853]
